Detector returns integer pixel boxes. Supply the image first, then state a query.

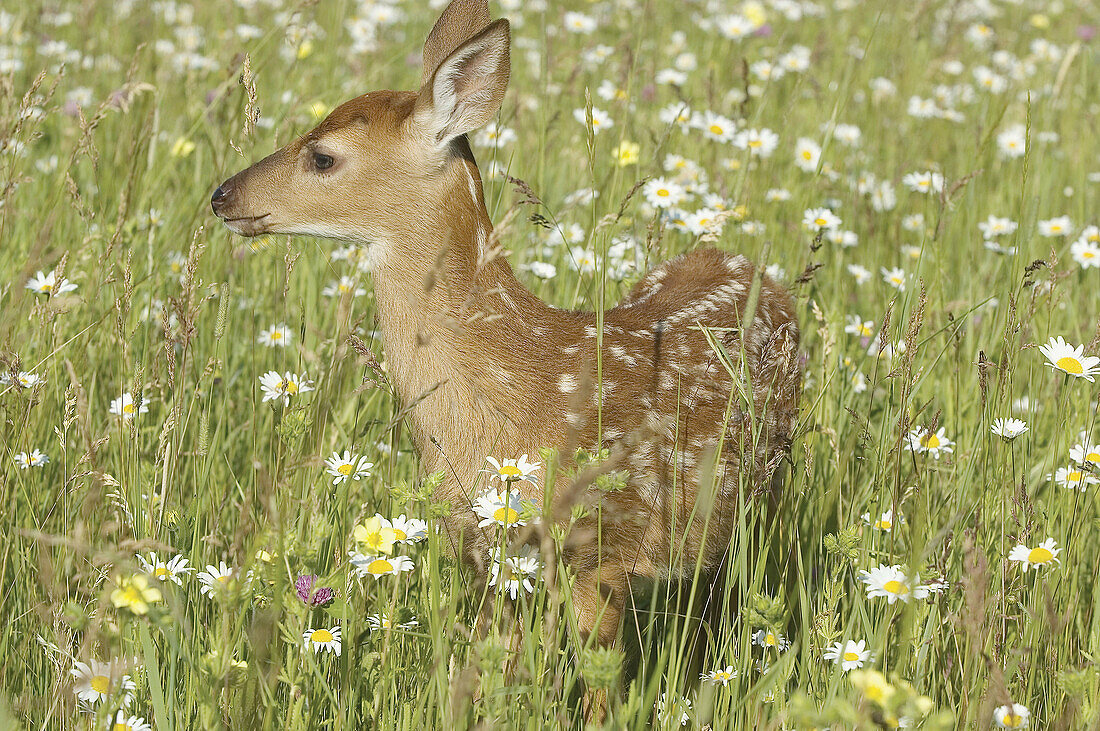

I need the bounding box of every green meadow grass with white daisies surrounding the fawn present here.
[0,0,1100,730]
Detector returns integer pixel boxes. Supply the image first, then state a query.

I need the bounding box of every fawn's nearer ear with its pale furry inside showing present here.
[413,19,512,146]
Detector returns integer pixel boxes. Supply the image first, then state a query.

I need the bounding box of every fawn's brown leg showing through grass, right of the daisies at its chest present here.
[573,563,629,723]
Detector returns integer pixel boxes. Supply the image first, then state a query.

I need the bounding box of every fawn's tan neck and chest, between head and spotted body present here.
[373,160,553,470]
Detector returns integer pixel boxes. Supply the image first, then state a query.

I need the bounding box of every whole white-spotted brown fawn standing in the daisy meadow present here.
[210,0,801,719]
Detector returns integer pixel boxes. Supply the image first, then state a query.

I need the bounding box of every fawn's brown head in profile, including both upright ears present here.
[210,0,510,269]
